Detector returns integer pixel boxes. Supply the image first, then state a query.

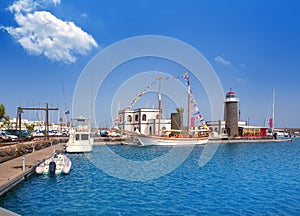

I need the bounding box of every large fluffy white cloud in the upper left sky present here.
[3,0,98,63]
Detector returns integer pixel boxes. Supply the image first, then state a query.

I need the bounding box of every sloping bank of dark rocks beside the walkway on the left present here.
[0,139,67,163]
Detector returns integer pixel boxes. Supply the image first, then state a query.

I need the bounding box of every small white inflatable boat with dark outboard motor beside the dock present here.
[35,153,72,175]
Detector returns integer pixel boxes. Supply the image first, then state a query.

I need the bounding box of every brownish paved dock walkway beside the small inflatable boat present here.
[0,144,63,196]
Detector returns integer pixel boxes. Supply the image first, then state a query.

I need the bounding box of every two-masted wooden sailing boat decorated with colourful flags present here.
[136,73,210,146]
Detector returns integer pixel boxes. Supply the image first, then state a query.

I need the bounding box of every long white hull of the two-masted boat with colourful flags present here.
[137,136,208,146]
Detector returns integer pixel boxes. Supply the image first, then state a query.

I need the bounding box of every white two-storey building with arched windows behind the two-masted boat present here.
[118,108,171,135]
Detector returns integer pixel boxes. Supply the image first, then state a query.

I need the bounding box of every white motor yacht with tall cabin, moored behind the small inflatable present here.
[66,118,94,153]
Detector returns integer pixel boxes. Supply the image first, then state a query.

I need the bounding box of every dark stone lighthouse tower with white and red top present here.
[224,91,239,137]
